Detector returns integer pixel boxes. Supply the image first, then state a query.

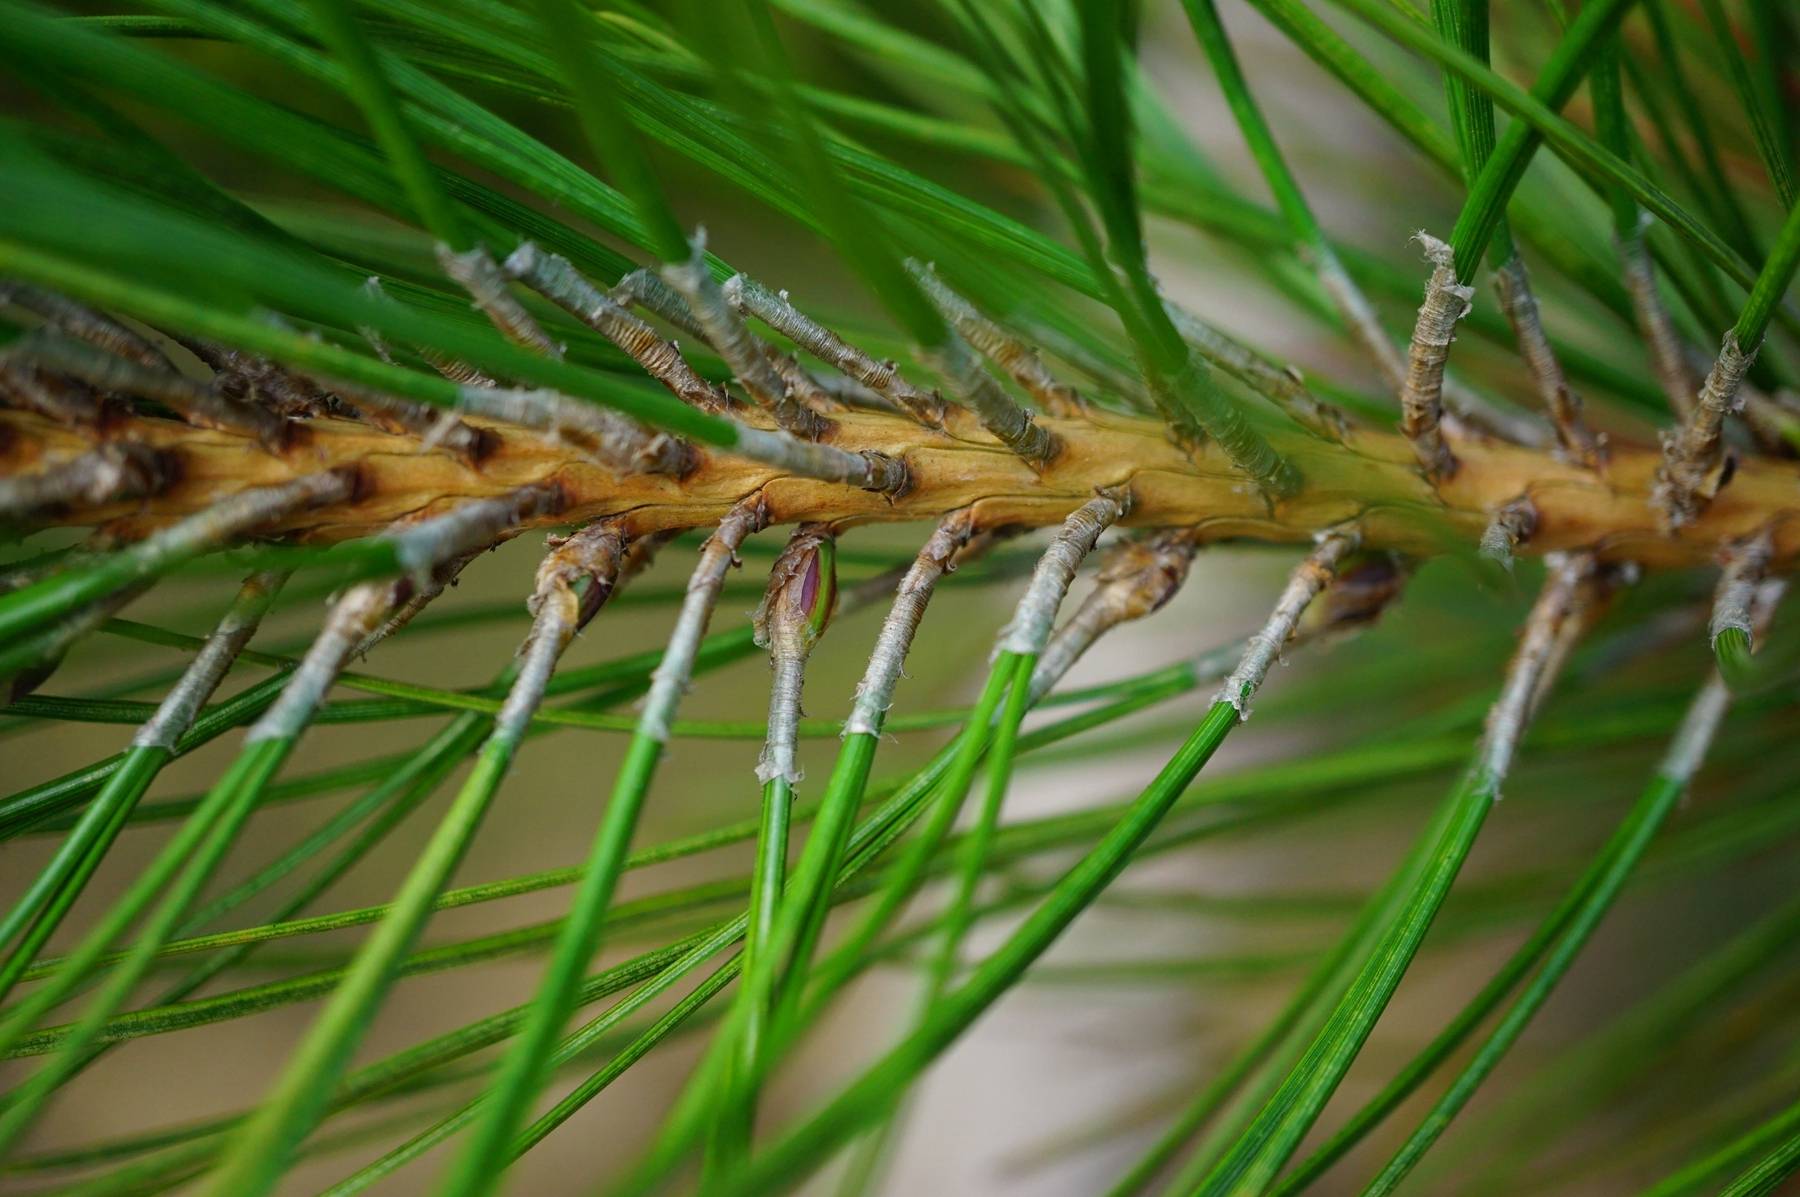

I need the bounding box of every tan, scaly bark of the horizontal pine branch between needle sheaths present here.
[10,401,1800,567]
